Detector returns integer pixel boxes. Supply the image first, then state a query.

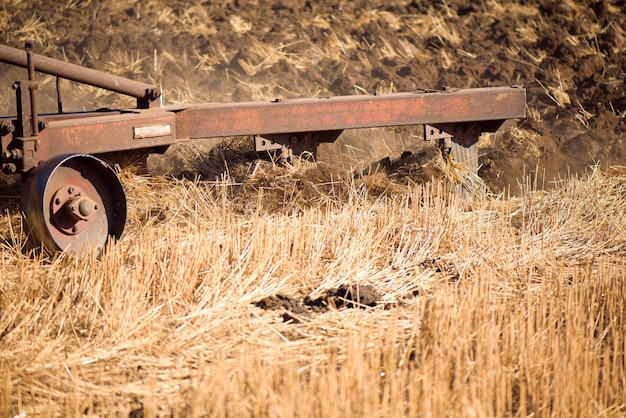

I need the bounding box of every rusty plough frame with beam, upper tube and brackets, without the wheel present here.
[0,45,526,173]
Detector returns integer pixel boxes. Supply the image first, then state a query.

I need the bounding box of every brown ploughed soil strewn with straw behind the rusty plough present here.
[0,0,626,189]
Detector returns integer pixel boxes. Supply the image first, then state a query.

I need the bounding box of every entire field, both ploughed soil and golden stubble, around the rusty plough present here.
[0,0,626,417]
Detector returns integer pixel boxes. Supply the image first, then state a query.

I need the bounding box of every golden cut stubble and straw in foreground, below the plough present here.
[0,165,626,416]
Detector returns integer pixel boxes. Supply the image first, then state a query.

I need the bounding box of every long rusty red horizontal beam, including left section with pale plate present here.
[5,87,526,164]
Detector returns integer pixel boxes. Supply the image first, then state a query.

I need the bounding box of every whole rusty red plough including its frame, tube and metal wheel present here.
[0,42,526,256]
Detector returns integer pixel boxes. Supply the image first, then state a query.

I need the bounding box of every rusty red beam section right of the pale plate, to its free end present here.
[166,86,526,139]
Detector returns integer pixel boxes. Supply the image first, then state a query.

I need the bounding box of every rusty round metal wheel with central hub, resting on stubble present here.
[21,154,126,257]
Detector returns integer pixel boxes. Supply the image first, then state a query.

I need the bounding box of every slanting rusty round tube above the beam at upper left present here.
[0,45,160,100]
